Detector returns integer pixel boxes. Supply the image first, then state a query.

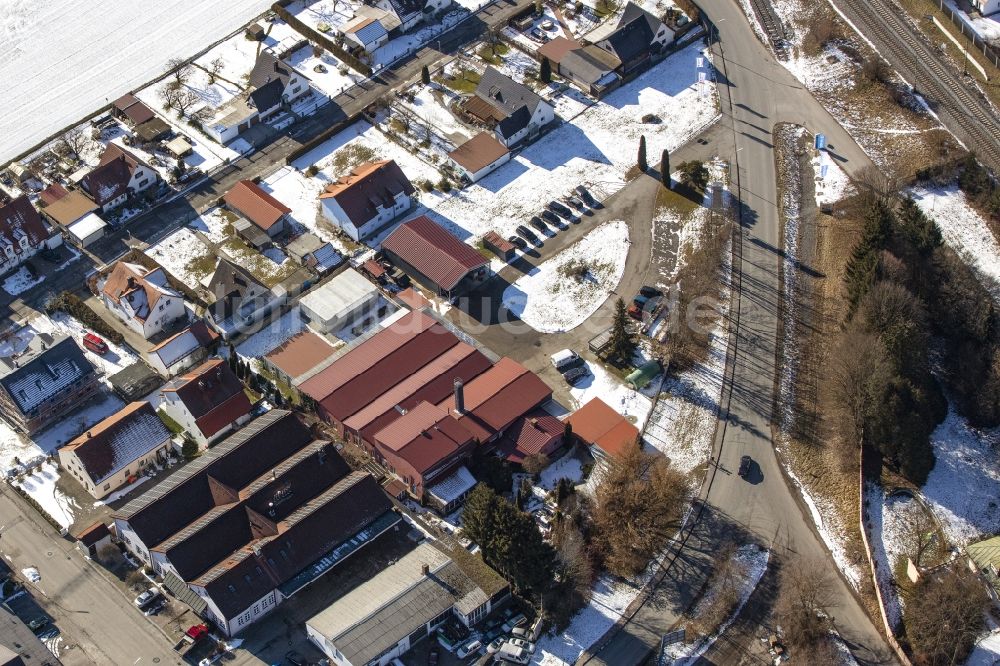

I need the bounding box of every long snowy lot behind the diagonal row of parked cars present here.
[414,45,718,244]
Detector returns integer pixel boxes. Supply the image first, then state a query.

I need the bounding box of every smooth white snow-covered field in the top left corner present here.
[0,0,270,164]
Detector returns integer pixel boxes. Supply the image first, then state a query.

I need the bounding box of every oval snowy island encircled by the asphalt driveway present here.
[503,220,629,333]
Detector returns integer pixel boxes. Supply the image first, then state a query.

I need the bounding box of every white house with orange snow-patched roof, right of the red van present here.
[99,261,187,340]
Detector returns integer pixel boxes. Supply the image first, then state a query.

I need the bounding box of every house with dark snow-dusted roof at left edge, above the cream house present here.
[0,326,100,436]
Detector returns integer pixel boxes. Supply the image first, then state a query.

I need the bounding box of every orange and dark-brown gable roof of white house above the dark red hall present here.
[319,160,416,227]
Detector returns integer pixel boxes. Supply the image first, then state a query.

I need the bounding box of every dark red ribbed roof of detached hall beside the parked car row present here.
[382,215,489,291]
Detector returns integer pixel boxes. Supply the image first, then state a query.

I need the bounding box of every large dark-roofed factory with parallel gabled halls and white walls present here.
[113,410,400,636]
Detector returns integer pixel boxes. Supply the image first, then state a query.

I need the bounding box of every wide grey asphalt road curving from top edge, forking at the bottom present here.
[579,0,893,666]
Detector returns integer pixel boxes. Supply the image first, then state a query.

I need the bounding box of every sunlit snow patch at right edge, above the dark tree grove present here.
[910,185,1000,303]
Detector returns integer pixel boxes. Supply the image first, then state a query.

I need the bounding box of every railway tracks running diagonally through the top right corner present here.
[835,0,1000,173]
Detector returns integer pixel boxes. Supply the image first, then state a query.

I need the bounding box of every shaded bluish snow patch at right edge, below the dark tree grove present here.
[922,411,1000,546]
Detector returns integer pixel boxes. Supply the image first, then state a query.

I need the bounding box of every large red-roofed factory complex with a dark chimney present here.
[299,311,552,500]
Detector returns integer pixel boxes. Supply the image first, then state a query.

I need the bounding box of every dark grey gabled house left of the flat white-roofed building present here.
[205,259,285,340]
